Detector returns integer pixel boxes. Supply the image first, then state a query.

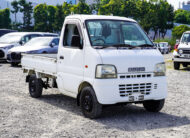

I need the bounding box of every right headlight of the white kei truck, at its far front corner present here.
[154,62,166,77]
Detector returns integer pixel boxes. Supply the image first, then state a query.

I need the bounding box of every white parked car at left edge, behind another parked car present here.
[0,32,58,60]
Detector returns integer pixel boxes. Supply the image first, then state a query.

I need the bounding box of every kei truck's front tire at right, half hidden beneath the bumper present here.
[143,99,165,112]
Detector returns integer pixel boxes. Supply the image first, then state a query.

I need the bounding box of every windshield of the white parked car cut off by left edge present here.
[0,34,22,44]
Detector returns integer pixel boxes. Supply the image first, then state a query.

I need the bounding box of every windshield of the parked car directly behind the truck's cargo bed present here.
[25,37,53,46]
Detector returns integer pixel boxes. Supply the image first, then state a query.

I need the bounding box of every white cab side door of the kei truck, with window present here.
[57,19,84,97]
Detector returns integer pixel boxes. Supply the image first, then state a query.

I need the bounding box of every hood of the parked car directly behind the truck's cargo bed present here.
[9,46,47,53]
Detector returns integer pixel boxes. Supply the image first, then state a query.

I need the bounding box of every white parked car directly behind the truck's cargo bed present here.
[7,37,59,66]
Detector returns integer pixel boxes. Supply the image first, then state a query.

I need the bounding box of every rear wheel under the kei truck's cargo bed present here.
[29,75,43,98]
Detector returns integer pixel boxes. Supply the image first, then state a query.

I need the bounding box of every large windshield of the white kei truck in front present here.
[86,20,153,46]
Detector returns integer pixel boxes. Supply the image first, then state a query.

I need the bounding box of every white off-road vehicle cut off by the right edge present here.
[173,31,190,70]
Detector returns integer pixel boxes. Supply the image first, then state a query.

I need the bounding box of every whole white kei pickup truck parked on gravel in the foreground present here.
[21,15,167,119]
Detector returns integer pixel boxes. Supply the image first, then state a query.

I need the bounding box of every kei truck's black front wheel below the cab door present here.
[80,86,102,119]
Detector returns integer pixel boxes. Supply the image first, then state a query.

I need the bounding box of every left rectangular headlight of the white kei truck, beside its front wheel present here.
[96,65,117,79]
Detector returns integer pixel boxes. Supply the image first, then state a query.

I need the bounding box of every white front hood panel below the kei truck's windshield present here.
[97,49,164,74]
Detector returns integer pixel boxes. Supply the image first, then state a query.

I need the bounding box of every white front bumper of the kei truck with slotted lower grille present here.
[93,73,167,104]
